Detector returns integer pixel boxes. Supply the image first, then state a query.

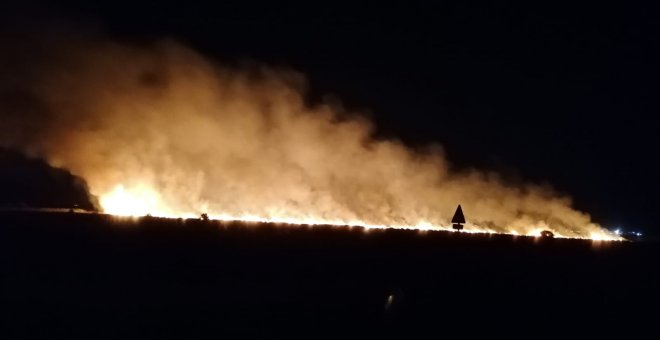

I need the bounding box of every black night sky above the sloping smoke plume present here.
[5,0,660,236]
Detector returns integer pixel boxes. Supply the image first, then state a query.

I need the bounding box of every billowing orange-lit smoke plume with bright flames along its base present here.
[0,26,610,238]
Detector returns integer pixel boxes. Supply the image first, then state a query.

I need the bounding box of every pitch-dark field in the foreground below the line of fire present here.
[0,212,660,339]
